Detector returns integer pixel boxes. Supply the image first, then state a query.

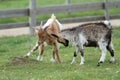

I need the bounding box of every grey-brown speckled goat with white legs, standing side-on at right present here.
[61,20,115,66]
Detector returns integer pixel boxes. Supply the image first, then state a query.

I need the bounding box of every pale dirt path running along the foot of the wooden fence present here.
[0,19,120,37]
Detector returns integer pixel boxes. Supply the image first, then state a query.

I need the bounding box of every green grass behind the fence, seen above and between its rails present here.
[0,0,120,23]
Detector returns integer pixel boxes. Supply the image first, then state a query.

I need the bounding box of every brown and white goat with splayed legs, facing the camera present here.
[24,14,69,63]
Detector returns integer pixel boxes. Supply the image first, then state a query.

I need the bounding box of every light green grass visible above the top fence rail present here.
[0,0,104,10]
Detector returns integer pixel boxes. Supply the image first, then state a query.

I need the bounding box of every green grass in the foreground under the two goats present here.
[0,27,120,80]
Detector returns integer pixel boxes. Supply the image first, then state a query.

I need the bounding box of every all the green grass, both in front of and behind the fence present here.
[0,0,120,80]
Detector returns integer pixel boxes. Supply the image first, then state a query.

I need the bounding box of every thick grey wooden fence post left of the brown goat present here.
[29,0,36,35]
